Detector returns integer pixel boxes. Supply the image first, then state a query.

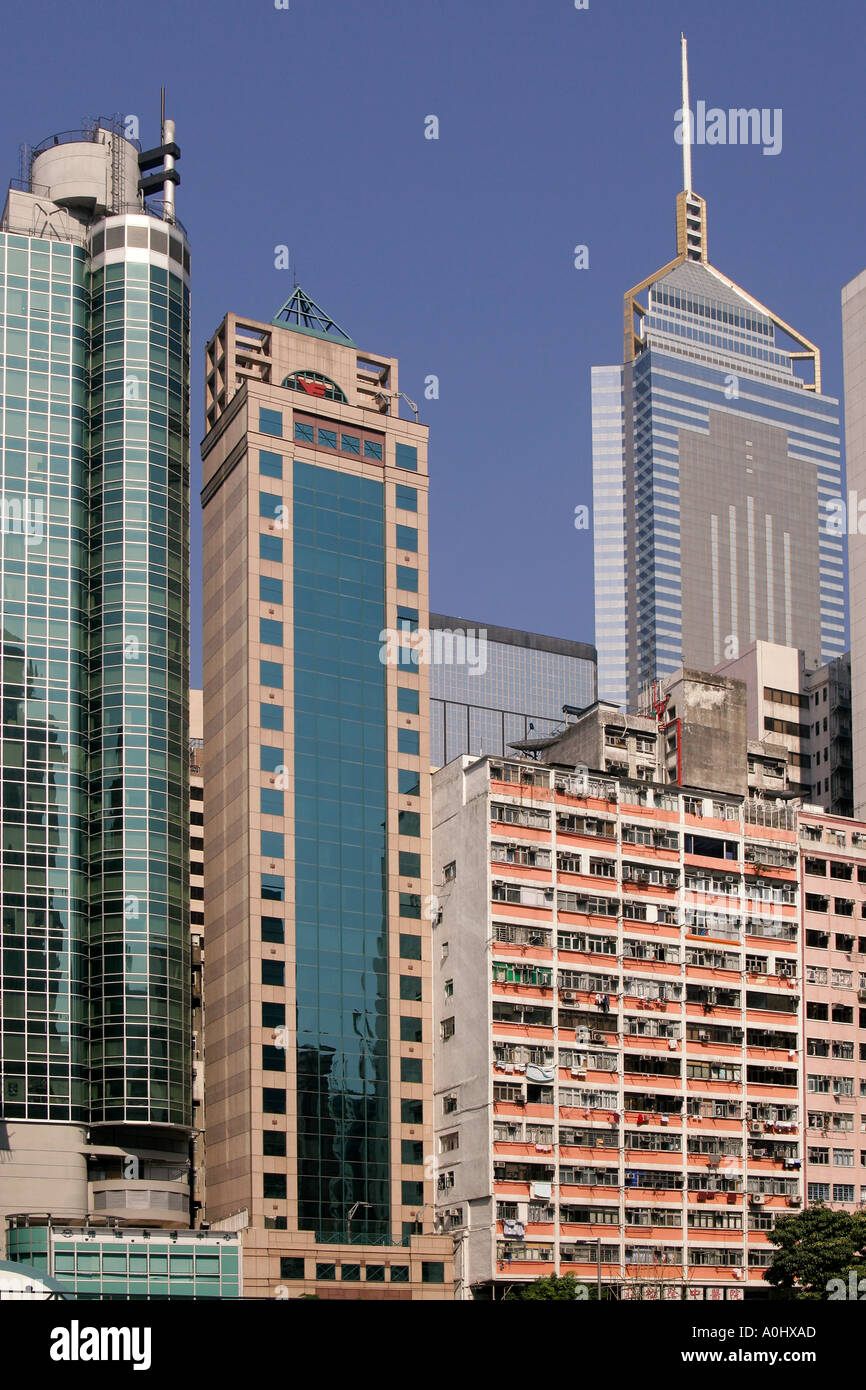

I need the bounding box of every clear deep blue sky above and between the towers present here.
[0,0,866,680]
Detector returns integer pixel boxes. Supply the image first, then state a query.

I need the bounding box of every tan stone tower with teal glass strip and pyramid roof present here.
[202,289,452,1298]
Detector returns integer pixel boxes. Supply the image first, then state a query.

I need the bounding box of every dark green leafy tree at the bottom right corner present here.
[765,1205,866,1300]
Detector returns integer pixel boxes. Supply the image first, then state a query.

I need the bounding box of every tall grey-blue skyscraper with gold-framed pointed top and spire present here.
[592,44,845,708]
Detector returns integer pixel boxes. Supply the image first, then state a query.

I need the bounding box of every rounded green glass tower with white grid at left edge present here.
[0,120,190,1245]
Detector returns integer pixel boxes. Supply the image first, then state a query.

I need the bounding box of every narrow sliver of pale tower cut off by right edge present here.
[842,270,866,816]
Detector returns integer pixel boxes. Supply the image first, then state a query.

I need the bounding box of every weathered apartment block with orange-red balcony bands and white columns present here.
[434,755,805,1298]
